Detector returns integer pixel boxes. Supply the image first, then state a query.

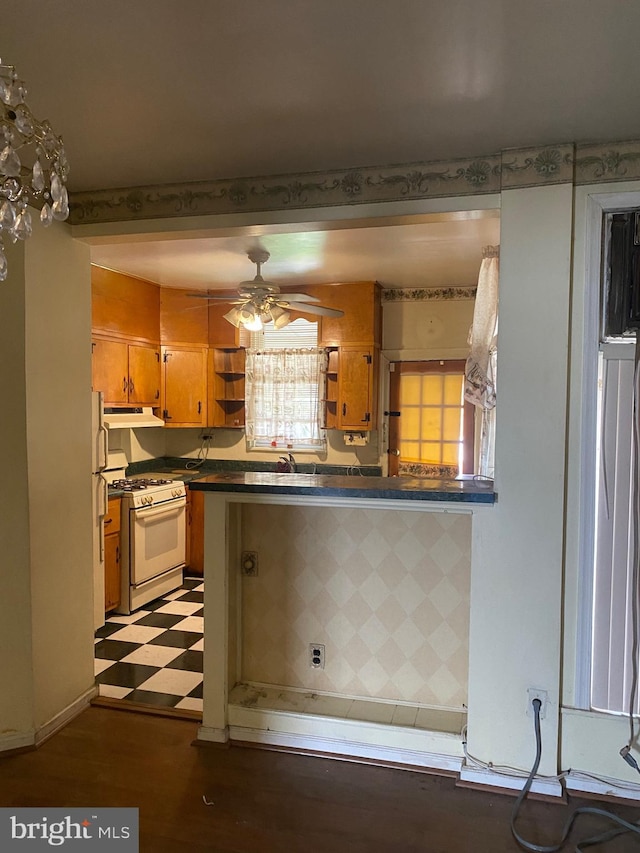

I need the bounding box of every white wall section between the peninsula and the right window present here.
[468,185,572,774]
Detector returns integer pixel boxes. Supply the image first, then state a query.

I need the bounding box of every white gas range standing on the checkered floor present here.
[110,475,187,614]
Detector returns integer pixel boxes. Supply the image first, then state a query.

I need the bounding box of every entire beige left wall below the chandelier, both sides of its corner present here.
[0,223,94,748]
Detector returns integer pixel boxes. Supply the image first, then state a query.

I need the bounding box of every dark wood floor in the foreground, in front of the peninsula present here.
[0,707,640,853]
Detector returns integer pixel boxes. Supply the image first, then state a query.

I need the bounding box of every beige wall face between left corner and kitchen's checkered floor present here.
[25,225,94,728]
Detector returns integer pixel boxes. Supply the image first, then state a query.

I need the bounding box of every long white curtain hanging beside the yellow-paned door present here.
[464,246,500,477]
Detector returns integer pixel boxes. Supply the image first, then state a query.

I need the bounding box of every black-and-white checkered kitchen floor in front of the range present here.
[95,578,204,712]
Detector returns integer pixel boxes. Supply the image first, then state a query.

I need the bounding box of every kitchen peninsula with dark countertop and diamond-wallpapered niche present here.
[190,471,496,771]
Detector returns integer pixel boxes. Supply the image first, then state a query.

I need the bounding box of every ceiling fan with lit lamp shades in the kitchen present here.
[192,249,344,332]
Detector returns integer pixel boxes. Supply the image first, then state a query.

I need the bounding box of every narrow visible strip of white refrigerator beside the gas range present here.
[91,391,109,630]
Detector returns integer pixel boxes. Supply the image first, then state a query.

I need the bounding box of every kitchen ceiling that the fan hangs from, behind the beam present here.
[86,211,500,289]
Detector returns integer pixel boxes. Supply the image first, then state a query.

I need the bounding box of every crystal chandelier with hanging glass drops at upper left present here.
[0,62,69,281]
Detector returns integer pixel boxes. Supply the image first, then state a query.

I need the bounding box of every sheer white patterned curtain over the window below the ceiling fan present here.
[245,348,328,449]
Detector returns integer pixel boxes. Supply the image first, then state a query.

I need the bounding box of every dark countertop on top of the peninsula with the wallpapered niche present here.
[189,471,496,504]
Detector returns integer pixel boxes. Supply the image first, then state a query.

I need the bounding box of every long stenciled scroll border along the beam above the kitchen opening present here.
[69,141,640,225]
